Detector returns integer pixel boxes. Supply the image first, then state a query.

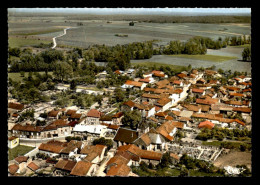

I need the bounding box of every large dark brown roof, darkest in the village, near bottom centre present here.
[114,128,138,143]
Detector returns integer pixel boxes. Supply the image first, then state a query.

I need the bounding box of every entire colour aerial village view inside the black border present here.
[7,8,252,178]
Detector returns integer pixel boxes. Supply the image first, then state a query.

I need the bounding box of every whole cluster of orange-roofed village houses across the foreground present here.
[8,69,252,176]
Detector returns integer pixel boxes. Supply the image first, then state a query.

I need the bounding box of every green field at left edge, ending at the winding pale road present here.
[8,37,52,48]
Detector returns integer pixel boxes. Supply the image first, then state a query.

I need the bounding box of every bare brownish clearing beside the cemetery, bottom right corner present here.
[214,151,252,169]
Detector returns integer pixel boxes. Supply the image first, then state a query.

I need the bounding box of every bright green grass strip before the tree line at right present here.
[170,54,237,62]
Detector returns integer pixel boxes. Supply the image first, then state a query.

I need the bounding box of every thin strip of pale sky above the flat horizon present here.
[8,7,251,15]
